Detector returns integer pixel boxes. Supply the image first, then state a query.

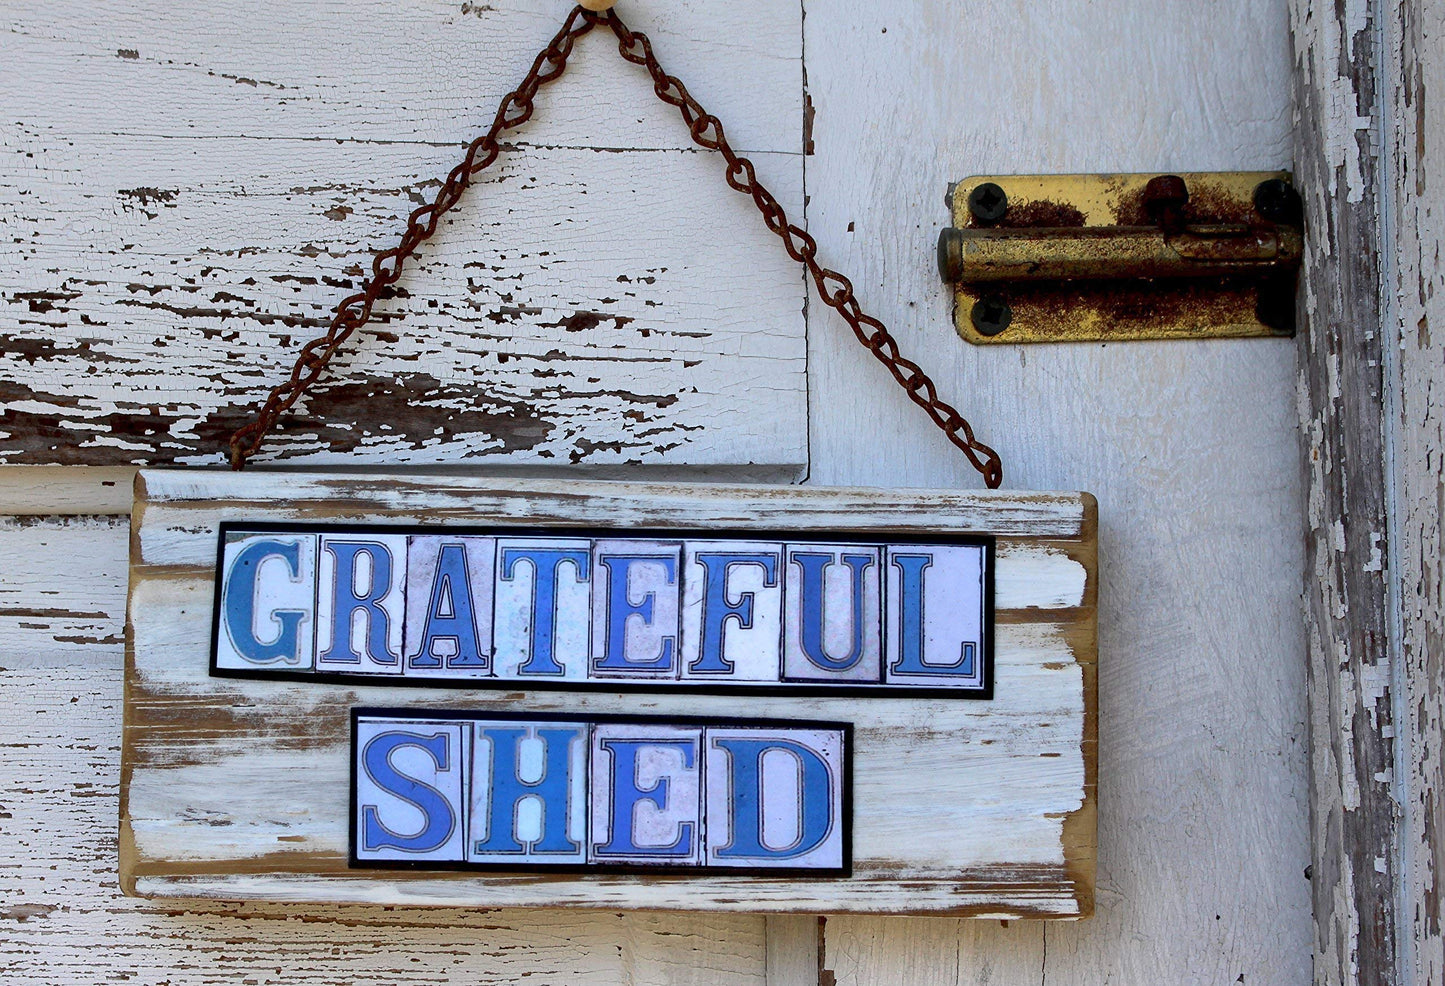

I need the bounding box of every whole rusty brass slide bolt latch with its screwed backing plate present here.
[938,172,1303,344]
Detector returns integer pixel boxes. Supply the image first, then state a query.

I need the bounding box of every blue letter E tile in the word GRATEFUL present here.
[591,541,682,680]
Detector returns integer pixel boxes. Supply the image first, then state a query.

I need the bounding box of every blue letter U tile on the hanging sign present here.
[783,544,883,684]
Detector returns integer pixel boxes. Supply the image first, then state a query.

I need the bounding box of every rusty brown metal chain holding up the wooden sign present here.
[230,7,1003,489]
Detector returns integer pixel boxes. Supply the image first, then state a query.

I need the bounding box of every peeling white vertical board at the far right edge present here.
[1380,0,1445,983]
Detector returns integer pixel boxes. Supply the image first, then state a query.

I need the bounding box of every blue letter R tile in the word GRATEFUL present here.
[316,532,406,674]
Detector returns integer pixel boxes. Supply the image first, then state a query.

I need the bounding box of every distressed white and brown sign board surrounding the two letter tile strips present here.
[120,471,1097,917]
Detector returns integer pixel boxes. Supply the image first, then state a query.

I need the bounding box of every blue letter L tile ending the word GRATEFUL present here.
[884,545,984,688]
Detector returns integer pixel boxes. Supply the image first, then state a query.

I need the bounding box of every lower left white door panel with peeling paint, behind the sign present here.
[0,519,780,986]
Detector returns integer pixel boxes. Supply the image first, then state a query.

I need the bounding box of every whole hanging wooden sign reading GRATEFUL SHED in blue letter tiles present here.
[120,471,1097,917]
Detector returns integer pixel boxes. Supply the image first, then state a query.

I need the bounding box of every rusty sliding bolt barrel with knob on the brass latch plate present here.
[938,175,1303,285]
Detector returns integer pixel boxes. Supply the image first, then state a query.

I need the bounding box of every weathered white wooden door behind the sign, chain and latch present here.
[0,0,1311,986]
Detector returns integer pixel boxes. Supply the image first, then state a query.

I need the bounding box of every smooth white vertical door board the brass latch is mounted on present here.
[805,0,1311,986]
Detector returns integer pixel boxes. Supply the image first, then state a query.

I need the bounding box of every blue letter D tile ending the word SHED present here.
[705,726,847,869]
